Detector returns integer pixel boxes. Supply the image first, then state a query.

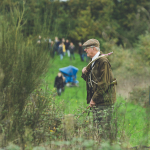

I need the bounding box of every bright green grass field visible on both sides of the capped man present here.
[42,54,150,146]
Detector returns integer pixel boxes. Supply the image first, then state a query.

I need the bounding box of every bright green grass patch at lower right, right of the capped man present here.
[116,97,150,146]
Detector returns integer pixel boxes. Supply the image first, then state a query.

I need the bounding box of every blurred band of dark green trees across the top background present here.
[0,0,150,47]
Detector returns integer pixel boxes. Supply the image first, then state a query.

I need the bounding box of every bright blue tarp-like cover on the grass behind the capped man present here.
[59,65,78,83]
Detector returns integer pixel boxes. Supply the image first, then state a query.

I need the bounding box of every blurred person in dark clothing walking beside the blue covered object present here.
[54,72,64,96]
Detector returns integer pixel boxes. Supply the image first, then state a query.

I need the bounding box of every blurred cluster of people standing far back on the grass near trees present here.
[37,35,87,61]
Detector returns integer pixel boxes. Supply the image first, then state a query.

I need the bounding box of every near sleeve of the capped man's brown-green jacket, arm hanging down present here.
[92,62,110,103]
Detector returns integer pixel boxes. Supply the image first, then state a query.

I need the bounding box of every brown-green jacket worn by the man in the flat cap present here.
[81,54,116,105]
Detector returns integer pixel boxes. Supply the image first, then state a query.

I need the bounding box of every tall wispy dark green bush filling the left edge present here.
[0,4,50,149]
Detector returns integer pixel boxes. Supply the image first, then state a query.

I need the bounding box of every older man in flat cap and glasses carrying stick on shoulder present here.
[81,39,116,139]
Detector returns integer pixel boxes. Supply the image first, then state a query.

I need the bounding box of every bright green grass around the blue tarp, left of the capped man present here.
[45,54,87,114]
